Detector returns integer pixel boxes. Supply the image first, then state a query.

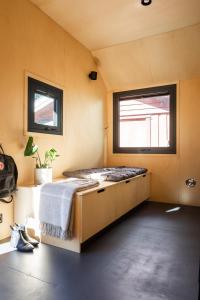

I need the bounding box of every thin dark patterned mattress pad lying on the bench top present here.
[63,166,147,182]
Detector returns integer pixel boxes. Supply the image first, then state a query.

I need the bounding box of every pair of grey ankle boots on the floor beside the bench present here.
[10,224,39,252]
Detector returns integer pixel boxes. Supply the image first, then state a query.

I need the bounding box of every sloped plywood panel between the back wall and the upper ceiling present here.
[93,24,200,91]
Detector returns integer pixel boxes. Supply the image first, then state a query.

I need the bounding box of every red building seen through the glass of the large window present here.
[120,95,170,147]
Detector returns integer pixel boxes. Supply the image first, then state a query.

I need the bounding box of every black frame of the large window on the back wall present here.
[113,84,176,154]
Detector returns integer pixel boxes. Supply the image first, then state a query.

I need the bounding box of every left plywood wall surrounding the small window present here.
[0,0,105,238]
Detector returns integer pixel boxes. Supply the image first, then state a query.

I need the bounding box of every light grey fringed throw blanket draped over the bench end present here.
[39,178,99,239]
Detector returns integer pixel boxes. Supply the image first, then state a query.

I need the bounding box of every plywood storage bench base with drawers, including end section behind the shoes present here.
[14,173,150,252]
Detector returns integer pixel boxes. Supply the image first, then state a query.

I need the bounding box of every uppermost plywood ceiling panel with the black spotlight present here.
[31,0,200,50]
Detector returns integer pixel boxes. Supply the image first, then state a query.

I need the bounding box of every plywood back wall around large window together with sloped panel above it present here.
[93,24,200,205]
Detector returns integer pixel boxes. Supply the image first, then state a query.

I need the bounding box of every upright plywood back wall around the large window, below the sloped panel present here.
[107,79,200,206]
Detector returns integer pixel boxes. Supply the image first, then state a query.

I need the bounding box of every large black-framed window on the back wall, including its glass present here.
[113,85,176,153]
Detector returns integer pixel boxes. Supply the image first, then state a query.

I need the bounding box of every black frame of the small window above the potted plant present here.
[27,77,63,135]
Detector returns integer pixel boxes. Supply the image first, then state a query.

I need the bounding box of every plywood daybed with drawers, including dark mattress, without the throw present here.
[42,167,150,252]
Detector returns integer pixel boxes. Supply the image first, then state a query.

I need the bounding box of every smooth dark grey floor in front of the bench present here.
[0,202,200,300]
